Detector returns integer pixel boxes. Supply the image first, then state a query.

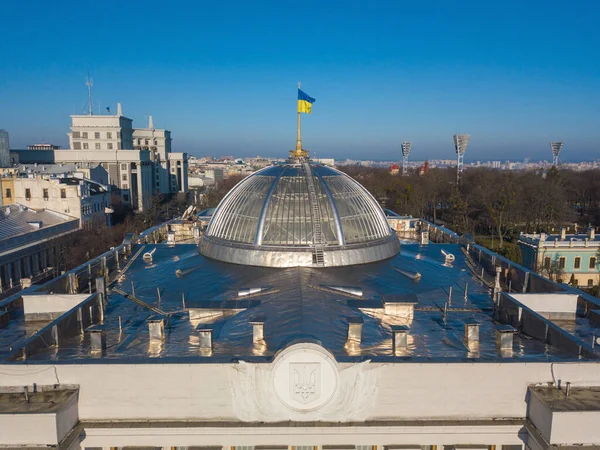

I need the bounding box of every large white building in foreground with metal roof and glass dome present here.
[0,161,600,450]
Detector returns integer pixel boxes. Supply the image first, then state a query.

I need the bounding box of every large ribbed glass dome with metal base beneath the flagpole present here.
[200,162,400,267]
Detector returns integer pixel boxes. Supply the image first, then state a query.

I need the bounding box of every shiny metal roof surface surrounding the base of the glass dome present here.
[0,230,595,363]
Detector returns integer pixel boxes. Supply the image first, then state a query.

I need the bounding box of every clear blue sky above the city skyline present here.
[0,0,600,160]
